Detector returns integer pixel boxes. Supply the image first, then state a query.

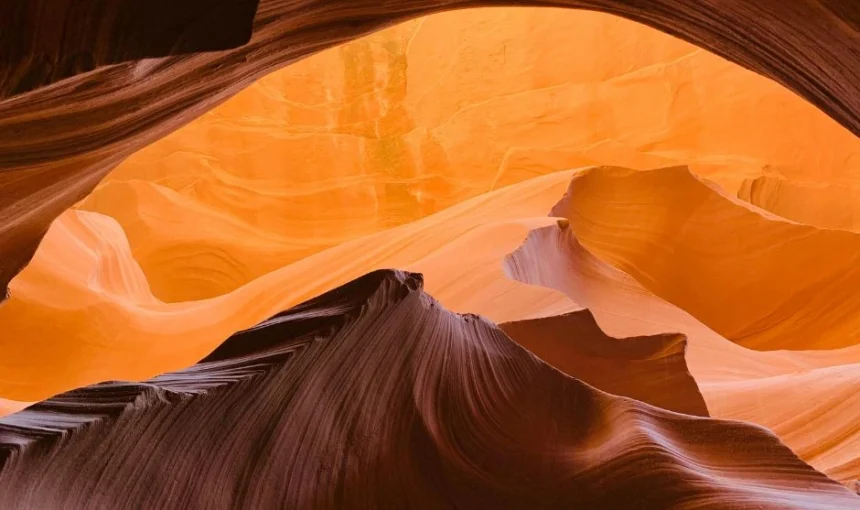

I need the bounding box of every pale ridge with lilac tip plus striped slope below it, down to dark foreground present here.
[505,214,860,484]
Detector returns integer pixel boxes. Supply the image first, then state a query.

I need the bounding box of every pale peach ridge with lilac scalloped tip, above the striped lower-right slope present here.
[504,220,860,382]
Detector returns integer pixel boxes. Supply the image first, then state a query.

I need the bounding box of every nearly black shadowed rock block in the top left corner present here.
[0,0,259,98]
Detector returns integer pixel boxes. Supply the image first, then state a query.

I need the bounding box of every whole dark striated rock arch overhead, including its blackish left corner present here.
[0,0,860,298]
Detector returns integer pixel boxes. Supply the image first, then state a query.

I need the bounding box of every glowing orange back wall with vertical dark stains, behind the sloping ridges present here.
[76,8,860,302]
